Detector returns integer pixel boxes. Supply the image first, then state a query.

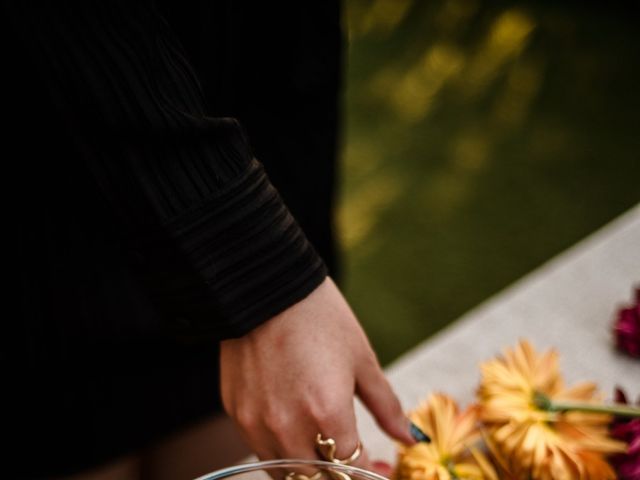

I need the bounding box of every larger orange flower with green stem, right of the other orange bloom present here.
[478,341,626,480]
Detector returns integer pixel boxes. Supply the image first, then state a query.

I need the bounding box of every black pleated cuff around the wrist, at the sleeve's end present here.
[150,159,327,339]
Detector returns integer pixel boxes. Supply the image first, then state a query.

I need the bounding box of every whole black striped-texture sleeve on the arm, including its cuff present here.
[8,1,327,339]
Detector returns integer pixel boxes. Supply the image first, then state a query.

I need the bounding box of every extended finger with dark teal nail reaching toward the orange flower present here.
[356,361,416,445]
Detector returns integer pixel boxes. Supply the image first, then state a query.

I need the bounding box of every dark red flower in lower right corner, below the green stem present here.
[611,388,640,480]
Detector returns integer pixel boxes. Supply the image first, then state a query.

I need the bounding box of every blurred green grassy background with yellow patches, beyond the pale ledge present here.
[339,0,640,363]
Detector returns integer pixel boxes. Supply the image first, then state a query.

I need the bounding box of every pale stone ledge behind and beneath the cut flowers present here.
[357,205,640,461]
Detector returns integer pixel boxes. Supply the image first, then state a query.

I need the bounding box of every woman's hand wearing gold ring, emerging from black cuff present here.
[220,277,414,469]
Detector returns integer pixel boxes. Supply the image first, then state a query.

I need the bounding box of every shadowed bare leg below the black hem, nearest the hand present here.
[140,414,251,480]
